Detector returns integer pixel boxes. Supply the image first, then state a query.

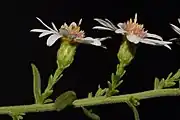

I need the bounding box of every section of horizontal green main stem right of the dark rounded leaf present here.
[73,88,180,107]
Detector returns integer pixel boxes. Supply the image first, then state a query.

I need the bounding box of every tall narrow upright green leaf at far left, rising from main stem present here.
[31,64,41,103]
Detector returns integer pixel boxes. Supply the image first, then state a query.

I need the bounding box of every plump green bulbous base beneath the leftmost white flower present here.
[57,40,77,69]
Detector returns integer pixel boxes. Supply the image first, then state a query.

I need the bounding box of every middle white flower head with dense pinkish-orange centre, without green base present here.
[93,14,172,49]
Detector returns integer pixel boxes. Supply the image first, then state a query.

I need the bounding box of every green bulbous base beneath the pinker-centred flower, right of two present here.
[117,36,136,67]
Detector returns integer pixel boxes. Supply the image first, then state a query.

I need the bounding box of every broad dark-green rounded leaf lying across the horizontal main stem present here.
[54,91,76,111]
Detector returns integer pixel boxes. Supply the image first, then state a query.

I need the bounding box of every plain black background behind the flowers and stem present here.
[0,0,180,120]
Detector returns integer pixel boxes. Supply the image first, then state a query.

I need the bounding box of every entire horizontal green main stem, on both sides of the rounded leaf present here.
[0,88,180,114]
